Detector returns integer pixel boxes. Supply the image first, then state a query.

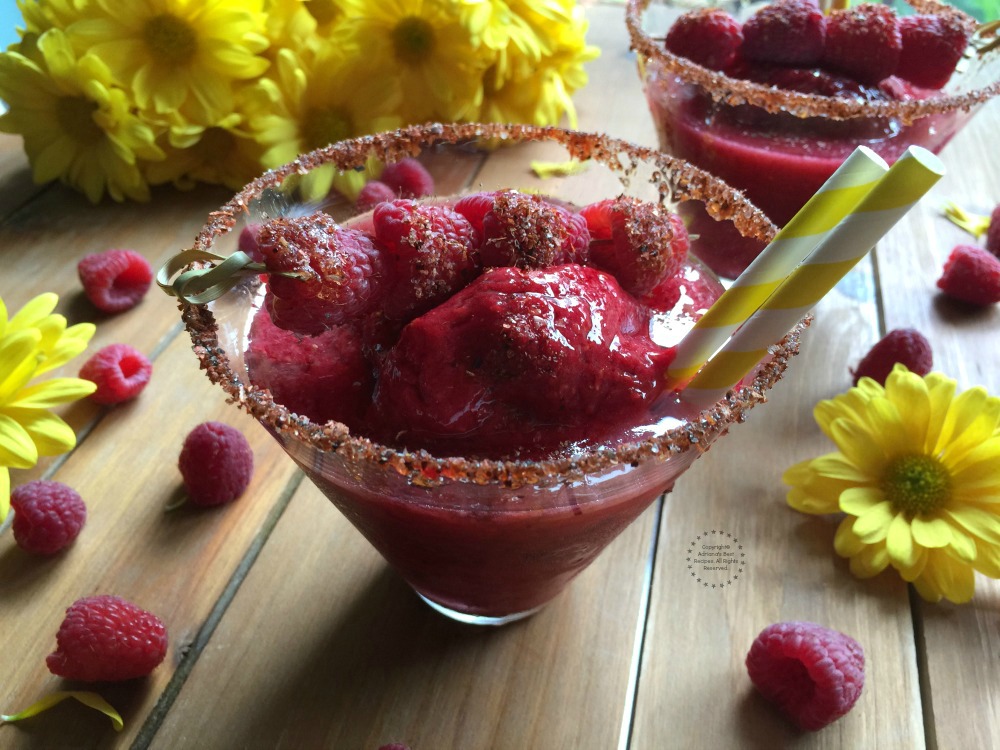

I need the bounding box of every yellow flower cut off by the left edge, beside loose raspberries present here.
[0,294,96,521]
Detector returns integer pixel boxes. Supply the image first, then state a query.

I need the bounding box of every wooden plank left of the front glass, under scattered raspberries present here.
[0,336,298,749]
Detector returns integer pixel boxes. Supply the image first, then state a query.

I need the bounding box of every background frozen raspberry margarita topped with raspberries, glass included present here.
[627,0,1000,277]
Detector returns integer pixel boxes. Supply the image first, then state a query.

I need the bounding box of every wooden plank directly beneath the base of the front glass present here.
[143,483,654,750]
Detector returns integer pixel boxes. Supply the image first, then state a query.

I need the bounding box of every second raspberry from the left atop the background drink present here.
[740,0,826,66]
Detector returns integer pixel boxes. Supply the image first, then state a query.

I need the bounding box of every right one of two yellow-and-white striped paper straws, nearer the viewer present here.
[684,146,944,404]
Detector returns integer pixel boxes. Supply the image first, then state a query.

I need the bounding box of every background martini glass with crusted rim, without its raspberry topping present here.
[625,0,1000,278]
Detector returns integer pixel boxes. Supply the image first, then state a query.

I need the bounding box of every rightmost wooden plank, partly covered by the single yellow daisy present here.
[879,101,1000,750]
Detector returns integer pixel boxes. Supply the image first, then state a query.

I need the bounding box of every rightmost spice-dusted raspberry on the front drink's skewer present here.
[580,196,690,297]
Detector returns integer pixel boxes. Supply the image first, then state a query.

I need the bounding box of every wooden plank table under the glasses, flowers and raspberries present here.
[0,5,1000,750]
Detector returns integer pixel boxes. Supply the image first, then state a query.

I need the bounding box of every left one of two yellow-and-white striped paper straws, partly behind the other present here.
[667,146,889,388]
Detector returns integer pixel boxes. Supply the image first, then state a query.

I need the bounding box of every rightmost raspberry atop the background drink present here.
[896,14,970,89]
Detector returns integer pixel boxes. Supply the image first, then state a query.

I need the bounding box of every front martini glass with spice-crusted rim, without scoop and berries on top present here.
[166,124,799,625]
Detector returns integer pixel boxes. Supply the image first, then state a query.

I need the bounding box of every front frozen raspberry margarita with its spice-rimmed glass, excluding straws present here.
[176,125,795,624]
